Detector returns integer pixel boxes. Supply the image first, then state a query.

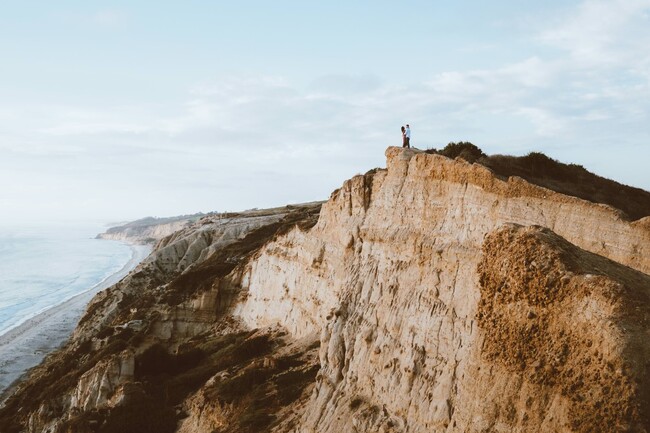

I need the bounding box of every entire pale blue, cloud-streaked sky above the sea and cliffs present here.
[0,0,650,224]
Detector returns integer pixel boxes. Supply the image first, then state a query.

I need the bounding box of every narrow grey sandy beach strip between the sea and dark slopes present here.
[0,245,151,394]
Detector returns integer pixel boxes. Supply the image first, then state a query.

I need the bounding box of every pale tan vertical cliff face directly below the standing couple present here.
[236,148,650,432]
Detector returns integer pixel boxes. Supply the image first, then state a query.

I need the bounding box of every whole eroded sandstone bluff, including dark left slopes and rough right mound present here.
[0,148,650,433]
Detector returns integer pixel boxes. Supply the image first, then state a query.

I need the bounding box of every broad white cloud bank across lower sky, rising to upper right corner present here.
[0,0,650,223]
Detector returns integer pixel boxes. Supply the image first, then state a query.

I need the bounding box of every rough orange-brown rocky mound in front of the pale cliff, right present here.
[472,227,650,432]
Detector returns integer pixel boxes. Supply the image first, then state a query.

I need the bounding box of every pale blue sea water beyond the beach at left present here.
[0,225,132,335]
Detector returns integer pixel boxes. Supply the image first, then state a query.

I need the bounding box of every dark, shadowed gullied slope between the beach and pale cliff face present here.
[0,203,320,433]
